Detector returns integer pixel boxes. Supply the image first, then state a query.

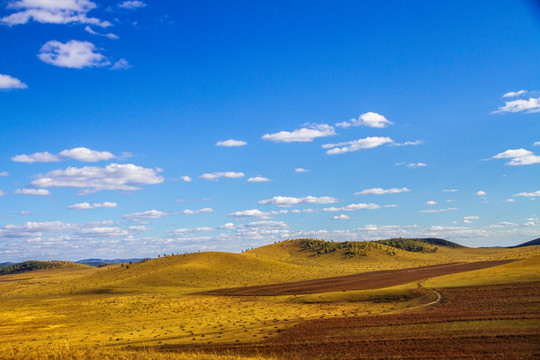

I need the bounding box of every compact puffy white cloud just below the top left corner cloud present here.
[38,40,110,69]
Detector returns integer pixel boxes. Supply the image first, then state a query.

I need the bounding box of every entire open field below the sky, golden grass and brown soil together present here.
[0,240,540,360]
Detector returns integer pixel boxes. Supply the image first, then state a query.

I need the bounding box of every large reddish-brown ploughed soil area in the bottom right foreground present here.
[161,282,540,360]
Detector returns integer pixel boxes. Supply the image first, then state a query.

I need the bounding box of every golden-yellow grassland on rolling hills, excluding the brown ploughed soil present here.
[0,240,540,360]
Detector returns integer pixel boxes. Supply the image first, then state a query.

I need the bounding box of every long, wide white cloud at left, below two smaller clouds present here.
[31,163,164,194]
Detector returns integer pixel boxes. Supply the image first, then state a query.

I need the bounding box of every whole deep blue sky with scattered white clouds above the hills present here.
[0,0,540,262]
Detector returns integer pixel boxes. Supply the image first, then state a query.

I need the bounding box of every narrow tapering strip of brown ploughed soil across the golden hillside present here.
[200,260,514,296]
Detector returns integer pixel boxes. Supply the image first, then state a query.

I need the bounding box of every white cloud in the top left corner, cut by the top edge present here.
[0,0,112,27]
